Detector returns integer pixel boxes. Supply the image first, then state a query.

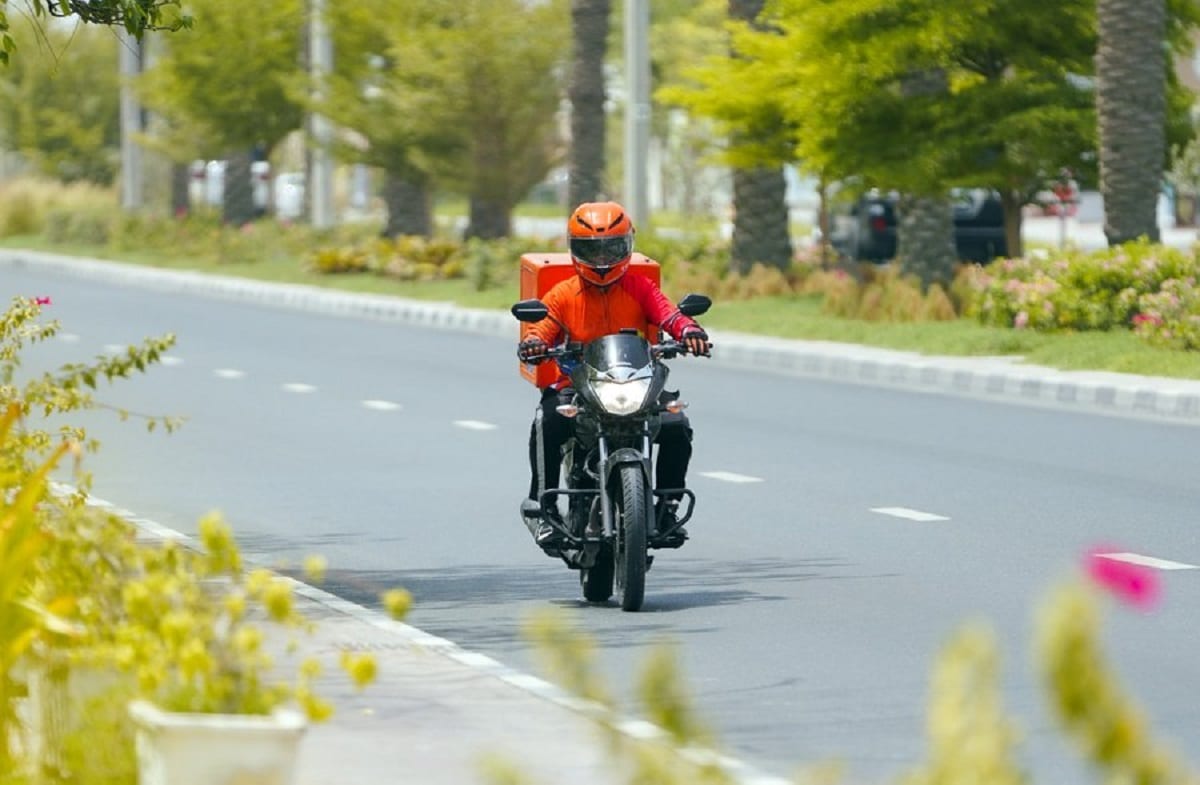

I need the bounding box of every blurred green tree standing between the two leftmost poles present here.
[139,0,306,224]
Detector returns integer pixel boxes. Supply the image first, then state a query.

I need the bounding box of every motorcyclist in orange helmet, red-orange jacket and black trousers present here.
[517,202,709,547]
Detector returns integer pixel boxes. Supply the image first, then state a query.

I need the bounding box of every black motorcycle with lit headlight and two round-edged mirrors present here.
[512,294,712,611]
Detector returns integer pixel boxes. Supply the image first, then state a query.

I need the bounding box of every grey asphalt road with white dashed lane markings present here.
[4,269,1200,785]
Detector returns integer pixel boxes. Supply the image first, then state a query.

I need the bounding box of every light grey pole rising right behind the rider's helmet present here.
[624,0,650,228]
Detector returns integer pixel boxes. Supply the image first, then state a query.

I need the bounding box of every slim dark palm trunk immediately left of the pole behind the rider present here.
[566,0,612,209]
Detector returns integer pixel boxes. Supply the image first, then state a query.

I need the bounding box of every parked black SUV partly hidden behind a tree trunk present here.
[829,188,1008,264]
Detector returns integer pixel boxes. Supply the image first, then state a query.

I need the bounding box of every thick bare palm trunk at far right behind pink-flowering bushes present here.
[1096,0,1166,245]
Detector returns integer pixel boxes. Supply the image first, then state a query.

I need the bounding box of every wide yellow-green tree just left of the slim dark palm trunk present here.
[328,0,569,238]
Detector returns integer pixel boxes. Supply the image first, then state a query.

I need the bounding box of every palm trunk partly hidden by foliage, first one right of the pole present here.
[728,0,792,272]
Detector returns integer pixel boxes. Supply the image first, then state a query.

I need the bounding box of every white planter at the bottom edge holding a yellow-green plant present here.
[130,701,307,785]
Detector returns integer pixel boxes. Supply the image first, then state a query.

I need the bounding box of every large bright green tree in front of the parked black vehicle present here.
[760,0,1094,282]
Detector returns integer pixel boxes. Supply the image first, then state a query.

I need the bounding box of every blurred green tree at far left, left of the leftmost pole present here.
[0,24,120,185]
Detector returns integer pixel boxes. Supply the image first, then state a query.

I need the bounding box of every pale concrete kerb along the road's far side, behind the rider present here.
[0,251,1200,425]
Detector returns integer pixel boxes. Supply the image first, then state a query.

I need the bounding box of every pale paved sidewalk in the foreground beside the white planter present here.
[282,583,785,785]
